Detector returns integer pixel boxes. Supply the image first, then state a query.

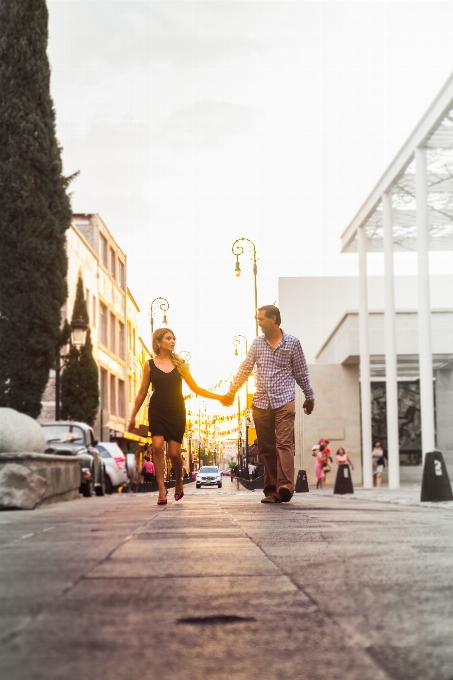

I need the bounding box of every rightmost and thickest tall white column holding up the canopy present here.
[415,148,435,456]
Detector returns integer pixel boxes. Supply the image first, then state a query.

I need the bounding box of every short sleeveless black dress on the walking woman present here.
[148,359,186,444]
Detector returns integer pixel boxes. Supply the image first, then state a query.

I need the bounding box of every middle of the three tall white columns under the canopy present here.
[382,193,400,489]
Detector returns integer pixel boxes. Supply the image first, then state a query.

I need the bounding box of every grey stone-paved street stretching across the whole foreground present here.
[0,482,453,680]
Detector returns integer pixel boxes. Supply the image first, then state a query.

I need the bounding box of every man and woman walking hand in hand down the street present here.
[128,305,314,505]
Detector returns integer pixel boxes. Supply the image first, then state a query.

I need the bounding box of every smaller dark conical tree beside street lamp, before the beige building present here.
[61,274,99,425]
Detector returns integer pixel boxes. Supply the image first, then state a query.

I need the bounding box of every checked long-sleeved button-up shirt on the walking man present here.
[231,331,314,409]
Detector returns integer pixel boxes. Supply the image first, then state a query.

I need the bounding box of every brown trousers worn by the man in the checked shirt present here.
[253,401,295,498]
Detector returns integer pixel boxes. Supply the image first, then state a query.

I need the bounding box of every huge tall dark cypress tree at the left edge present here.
[0,0,72,418]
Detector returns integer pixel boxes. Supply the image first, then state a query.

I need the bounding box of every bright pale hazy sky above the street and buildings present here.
[48,0,453,398]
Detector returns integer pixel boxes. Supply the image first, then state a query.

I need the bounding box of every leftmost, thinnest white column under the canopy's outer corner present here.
[357,227,373,489]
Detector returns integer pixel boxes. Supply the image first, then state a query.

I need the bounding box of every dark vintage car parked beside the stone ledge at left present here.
[41,420,106,496]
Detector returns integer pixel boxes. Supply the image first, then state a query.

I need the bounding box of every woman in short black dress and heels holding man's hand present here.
[128,328,226,505]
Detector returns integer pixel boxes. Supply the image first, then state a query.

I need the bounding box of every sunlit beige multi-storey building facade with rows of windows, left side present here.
[40,214,147,450]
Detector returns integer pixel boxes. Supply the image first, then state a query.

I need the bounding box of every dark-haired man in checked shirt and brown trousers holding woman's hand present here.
[222,305,314,503]
